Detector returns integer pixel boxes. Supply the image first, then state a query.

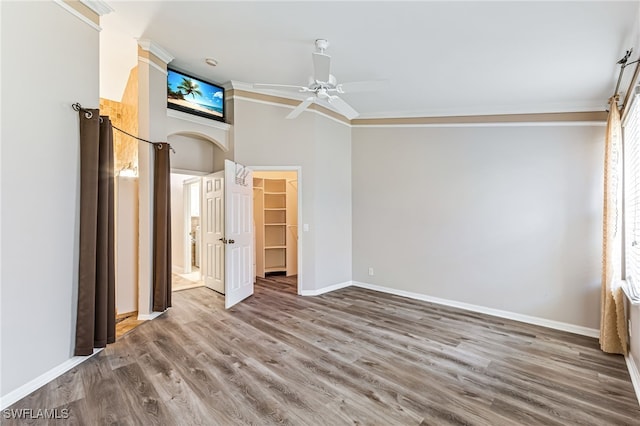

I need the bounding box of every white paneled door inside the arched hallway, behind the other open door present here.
[205,171,225,294]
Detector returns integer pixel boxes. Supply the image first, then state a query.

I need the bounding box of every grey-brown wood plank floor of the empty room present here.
[2,277,640,426]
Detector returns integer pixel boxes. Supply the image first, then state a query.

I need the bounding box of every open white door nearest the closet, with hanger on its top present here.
[224,160,254,309]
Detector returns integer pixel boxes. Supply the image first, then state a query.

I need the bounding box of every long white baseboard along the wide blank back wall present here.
[353,281,600,338]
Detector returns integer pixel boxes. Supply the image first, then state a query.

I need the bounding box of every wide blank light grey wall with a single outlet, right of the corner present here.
[353,126,604,329]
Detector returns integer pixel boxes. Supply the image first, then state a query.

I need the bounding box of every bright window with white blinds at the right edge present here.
[622,93,640,299]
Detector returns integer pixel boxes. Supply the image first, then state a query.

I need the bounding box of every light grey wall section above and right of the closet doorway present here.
[233,99,351,291]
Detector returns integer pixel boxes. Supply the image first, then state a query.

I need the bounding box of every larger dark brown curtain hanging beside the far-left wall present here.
[75,109,116,355]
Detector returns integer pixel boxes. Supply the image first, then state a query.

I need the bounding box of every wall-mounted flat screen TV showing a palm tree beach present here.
[167,68,225,121]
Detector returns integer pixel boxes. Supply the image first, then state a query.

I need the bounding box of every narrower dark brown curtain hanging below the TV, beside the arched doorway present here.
[153,143,171,312]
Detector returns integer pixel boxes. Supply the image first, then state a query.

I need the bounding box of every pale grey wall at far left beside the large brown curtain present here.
[0,2,99,397]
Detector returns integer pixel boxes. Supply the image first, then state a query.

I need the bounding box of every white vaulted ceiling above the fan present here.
[101,0,640,117]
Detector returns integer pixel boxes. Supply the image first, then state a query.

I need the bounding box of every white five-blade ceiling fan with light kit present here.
[253,39,385,120]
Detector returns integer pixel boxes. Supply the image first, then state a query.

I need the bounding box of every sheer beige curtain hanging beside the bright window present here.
[600,96,627,354]
